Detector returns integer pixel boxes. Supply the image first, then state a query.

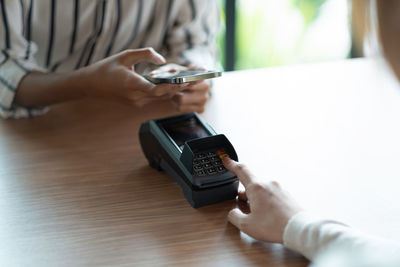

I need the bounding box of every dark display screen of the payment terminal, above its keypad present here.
[163,117,210,150]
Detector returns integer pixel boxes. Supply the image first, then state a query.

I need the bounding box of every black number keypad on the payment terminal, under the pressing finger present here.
[193,149,228,176]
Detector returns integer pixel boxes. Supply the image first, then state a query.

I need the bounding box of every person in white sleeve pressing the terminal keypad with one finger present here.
[223,0,400,267]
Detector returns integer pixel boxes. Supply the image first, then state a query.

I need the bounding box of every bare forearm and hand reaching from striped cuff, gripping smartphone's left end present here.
[16,48,188,107]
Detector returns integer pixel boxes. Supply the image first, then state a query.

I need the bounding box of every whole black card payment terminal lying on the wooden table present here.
[139,113,239,208]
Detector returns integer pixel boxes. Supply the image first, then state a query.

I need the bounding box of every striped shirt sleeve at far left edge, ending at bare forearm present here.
[0,0,46,118]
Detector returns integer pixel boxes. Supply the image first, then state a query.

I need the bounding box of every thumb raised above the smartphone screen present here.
[121,47,166,67]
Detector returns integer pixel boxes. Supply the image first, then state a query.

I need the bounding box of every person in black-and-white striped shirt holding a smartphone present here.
[0,0,220,118]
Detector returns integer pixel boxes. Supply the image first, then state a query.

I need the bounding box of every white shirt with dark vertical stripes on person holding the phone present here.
[0,0,220,118]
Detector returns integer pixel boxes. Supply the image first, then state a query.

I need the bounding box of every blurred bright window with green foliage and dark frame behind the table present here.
[218,0,363,71]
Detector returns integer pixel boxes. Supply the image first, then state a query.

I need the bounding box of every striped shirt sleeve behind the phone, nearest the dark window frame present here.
[164,0,220,69]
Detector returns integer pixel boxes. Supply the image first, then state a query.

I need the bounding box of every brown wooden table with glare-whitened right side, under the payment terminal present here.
[0,60,400,266]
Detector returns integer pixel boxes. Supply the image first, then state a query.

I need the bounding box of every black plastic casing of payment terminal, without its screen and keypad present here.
[139,113,239,208]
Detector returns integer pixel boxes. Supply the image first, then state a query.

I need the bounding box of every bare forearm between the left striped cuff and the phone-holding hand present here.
[15,71,85,107]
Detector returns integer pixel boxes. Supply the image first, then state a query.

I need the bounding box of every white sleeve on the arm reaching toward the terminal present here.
[283,212,400,266]
